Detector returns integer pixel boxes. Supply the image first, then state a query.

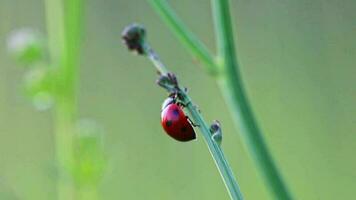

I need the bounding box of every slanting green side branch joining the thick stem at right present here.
[149,0,217,75]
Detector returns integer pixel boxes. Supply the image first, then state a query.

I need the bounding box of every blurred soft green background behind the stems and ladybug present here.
[0,0,356,200]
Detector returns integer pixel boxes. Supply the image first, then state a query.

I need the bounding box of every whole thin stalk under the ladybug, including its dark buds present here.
[122,24,243,200]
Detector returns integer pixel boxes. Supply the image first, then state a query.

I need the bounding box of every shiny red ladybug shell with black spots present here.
[161,103,196,142]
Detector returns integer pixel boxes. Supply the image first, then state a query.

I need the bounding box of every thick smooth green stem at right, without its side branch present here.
[212,0,292,200]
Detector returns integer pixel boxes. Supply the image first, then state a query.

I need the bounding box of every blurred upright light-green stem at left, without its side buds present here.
[45,0,82,200]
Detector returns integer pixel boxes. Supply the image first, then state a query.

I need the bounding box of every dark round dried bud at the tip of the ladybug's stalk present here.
[121,24,146,55]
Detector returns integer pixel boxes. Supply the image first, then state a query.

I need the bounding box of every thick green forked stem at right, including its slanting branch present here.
[150,0,292,200]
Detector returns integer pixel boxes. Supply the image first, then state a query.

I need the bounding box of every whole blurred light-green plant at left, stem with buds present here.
[8,0,105,200]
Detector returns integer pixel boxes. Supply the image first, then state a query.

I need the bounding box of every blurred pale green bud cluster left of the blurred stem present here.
[7,28,55,111]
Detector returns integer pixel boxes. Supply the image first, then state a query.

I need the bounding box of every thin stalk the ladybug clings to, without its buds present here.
[144,44,243,200]
